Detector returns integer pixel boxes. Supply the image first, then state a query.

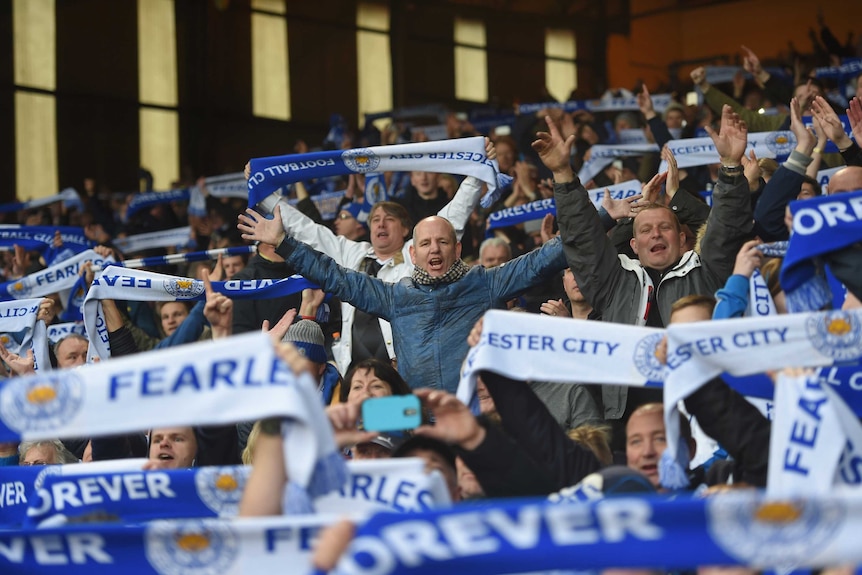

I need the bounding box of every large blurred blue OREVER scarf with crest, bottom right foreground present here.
[334,490,862,575]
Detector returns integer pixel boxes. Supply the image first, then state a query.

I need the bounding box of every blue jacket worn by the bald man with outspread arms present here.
[276,238,567,393]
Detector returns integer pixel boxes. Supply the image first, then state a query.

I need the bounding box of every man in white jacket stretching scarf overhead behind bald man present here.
[251,138,496,374]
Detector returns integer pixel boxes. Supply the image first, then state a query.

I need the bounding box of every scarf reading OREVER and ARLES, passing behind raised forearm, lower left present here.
[18,458,451,528]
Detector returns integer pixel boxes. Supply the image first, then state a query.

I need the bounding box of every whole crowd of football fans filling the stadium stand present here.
[0,30,862,570]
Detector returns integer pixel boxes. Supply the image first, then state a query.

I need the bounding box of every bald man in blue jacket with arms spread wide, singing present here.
[237,213,567,393]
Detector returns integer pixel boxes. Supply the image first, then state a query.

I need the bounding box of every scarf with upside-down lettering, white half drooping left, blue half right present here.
[84,266,316,359]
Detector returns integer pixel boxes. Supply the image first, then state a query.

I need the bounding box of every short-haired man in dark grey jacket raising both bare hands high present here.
[544,106,752,447]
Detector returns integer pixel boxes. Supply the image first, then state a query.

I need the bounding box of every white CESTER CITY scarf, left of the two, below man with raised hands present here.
[457,310,665,405]
